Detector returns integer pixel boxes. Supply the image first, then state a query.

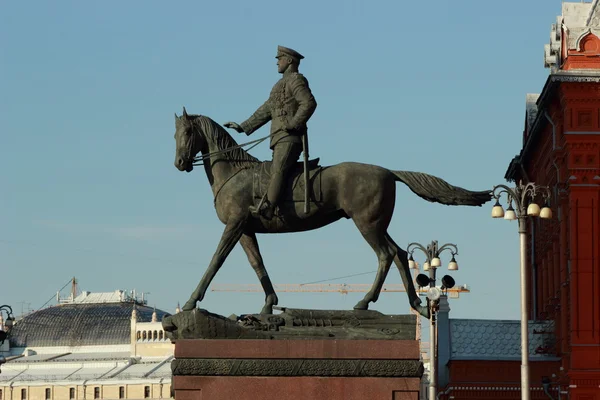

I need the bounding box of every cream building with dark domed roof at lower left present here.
[0,290,173,400]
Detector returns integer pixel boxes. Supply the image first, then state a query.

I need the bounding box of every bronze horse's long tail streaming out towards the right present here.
[390,171,492,207]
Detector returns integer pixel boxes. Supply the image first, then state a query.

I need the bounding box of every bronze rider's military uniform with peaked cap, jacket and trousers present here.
[240,46,317,219]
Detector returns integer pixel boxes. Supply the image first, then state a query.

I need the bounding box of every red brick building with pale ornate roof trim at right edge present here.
[439,0,600,400]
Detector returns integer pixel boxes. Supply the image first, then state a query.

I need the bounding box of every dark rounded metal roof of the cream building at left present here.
[10,302,168,347]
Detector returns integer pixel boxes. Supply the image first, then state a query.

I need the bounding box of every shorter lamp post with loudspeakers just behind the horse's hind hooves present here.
[406,240,458,399]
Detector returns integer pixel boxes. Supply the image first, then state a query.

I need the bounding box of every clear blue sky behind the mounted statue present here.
[0,0,561,319]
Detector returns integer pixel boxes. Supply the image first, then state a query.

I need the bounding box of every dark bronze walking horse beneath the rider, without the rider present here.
[175,108,491,318]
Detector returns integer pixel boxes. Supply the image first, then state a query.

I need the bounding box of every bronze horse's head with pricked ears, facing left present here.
[175,107,202,172]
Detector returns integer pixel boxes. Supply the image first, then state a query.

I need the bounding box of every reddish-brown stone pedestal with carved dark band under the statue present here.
[172,338,423,400]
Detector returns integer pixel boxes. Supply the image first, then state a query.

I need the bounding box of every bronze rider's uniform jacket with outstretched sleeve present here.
[240,72,317,148]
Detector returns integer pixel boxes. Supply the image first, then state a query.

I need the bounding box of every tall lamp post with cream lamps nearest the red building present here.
[492,182,552,400]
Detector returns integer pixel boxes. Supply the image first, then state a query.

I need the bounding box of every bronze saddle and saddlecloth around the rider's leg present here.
[252,158,323,205]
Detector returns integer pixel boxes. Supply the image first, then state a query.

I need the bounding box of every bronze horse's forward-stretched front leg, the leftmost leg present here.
[183,220,245,311]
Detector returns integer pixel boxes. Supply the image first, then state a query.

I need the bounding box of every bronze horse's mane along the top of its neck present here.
[190,115,260,167]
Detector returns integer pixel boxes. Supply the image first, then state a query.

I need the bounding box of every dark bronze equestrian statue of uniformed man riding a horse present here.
[175,46,491,318]
